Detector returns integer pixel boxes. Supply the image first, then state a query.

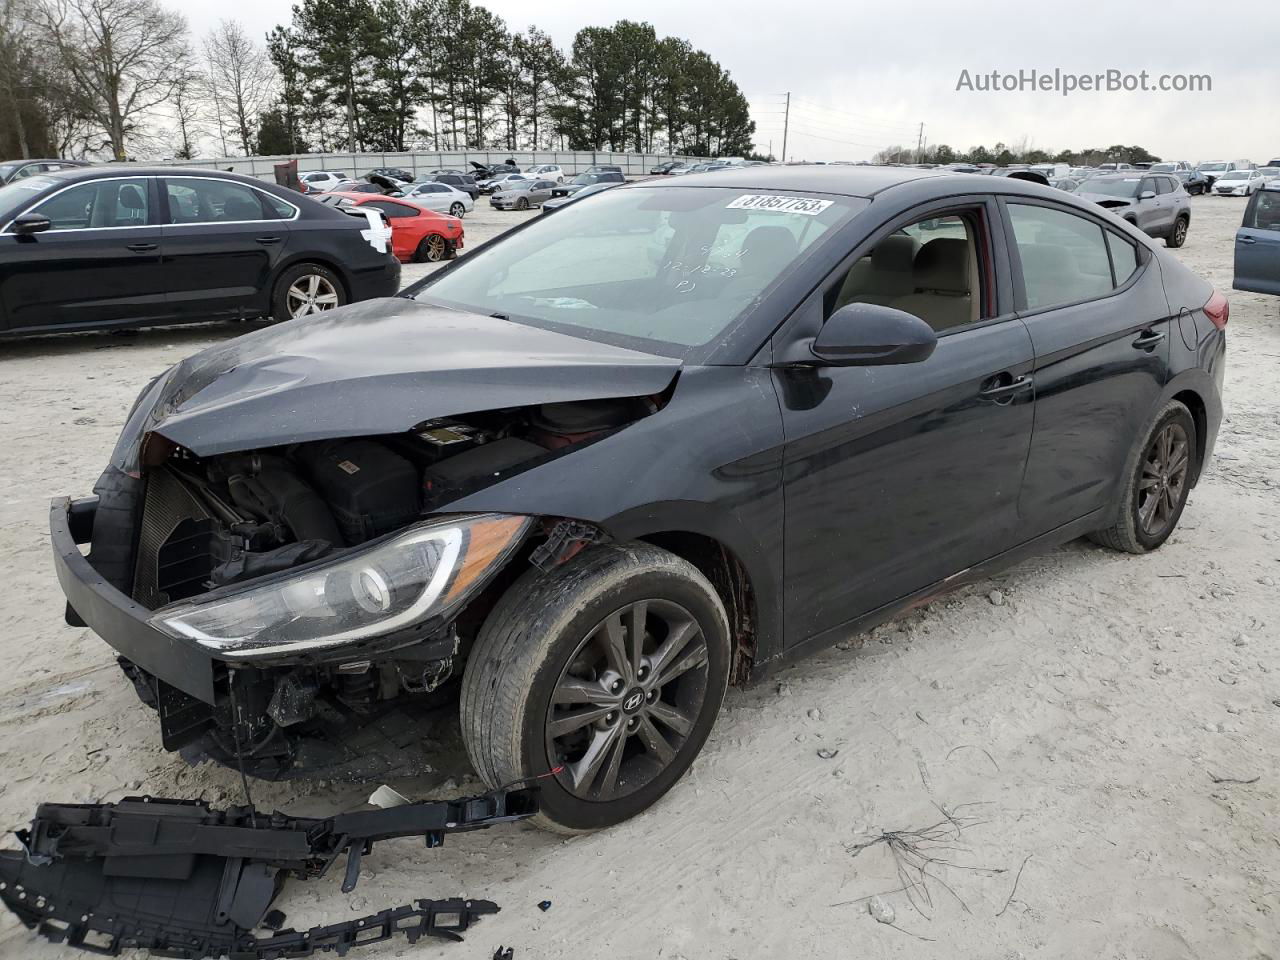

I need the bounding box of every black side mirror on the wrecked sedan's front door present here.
[809,303,938,366]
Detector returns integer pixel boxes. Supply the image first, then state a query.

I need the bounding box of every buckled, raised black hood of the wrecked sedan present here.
[124,297,680,460]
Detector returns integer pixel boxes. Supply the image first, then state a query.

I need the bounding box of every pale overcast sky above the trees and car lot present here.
[175,0,1280,164]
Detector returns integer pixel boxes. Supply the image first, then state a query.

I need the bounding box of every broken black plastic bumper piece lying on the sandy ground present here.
[0,790,536,960]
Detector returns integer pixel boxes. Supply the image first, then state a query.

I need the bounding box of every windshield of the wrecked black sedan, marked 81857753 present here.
[416,187,867,356]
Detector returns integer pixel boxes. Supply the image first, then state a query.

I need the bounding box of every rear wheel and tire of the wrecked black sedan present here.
[1089,401,1199,553]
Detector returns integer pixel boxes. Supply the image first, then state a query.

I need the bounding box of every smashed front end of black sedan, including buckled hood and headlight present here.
[50,300,678,780]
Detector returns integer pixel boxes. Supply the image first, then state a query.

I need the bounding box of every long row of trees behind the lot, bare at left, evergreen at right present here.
[0,0,755,160]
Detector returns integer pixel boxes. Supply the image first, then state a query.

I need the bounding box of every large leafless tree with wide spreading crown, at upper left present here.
[36,0,187,160]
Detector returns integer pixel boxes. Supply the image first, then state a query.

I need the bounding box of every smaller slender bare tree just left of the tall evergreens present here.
[205,20,275,156]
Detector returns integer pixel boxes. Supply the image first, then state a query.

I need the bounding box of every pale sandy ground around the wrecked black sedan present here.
[0,197,1280,960]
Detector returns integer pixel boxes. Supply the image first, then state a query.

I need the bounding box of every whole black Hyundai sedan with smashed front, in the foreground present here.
[51,166,1228,831]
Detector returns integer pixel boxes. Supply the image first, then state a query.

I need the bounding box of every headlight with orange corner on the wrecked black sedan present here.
[150,513,532,659]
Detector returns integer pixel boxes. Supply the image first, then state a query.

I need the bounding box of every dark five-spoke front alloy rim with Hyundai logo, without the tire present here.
[545,599,708,801]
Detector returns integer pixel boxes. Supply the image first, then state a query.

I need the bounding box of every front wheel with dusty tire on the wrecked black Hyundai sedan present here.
[461,543,731,833]
